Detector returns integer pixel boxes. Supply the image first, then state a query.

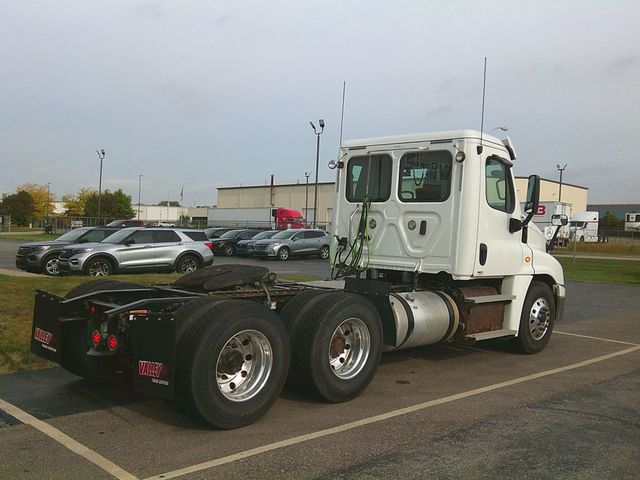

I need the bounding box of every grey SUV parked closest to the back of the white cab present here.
[253,229,329,260]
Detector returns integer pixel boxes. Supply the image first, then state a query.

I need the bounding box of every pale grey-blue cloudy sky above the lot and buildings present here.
[0,0,640,206]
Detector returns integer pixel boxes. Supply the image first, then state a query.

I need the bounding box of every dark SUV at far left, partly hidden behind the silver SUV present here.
[16,227,118,275]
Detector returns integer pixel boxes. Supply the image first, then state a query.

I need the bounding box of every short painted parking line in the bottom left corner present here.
[0,398,137,480]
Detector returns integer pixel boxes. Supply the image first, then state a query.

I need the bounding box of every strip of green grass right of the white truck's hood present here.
[557,257,640,285]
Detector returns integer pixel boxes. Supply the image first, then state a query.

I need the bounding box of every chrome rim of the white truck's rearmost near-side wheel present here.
[216,330,273,402]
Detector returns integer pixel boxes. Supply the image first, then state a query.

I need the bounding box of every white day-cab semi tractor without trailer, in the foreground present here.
[31,130,566,429]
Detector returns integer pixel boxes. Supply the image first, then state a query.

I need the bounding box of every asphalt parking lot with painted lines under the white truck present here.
[0,242,640,479]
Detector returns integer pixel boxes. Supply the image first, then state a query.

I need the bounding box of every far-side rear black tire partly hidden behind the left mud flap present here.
[60,280,141,382]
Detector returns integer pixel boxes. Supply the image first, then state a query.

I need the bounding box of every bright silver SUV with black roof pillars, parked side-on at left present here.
[58,227,213,277]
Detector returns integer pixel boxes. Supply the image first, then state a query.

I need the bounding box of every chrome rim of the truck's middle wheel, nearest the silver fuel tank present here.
[329,318,371,380]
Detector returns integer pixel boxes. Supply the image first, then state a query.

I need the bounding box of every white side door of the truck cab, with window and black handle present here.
[473,152,531,277]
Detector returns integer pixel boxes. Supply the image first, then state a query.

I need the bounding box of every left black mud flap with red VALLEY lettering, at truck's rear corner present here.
[31,290,64,363]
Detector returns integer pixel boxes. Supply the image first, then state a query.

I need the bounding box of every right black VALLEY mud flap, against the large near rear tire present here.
[130,314,176,398]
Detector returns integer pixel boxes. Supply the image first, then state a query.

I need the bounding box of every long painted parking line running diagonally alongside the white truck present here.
[146,345,640,480]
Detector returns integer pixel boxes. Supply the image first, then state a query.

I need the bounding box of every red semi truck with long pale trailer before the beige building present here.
[207,207,305,230]
